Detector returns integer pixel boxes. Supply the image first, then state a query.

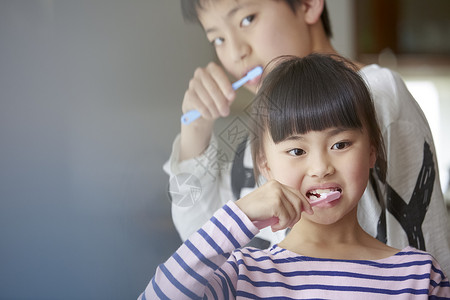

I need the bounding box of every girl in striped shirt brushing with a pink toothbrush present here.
[140,54,450,299]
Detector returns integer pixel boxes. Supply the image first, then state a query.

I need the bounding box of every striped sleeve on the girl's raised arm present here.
[138,201,258,300]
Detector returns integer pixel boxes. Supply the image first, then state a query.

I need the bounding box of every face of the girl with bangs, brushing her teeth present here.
[259,128,376,224]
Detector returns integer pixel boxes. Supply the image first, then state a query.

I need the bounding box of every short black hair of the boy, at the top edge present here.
[181,0,333,39]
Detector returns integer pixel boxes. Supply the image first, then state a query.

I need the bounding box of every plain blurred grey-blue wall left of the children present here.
[0,0,212,299]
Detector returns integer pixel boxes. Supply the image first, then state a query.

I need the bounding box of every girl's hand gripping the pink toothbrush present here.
[236,180,314,231]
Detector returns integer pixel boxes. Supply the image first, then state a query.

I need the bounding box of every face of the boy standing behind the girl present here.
[198,0,314,92]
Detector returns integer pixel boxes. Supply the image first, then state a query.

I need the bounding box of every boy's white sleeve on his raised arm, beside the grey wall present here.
[163,135,236,241]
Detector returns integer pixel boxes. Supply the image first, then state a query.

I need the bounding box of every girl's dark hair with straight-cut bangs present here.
[251,54,387,182]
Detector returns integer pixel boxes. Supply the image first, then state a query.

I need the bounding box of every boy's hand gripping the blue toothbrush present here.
[182,62,236,121]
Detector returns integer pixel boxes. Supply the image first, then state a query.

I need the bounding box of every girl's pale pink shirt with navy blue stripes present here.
[139,201,450,300]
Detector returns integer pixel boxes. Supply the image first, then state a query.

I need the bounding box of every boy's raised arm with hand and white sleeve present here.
[164,63,236,240]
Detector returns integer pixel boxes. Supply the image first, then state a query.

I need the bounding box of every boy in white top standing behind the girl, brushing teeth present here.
[165,0,450,274]
